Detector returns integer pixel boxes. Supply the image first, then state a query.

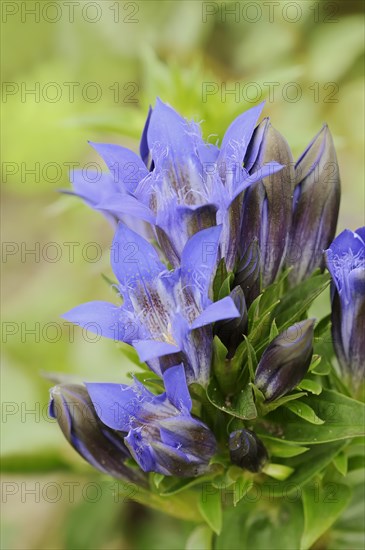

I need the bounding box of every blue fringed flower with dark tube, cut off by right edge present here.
[325,227,365,391]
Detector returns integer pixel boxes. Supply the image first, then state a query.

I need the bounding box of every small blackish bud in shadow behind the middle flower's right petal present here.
[214,286,247,359]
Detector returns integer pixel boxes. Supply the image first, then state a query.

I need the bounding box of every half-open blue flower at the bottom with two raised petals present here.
[87,365,216,477]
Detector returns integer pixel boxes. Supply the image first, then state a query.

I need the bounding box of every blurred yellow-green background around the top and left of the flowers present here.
[1,0,364,550]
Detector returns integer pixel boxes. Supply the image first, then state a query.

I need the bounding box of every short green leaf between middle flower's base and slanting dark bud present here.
[207,379,257,420]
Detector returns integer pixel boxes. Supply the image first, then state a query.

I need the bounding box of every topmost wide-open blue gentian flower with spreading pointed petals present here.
[68,100,282,270]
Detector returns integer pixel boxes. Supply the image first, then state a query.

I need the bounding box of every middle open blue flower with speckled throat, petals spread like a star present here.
[64,223,240,385]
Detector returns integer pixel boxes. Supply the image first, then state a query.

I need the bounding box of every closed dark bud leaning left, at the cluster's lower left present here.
[49,384,147,486]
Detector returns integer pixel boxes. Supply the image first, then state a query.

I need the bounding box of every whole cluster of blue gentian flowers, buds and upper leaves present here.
[50,100,365,487]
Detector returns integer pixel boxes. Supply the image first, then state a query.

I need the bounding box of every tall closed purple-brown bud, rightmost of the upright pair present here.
[286,125,341,285]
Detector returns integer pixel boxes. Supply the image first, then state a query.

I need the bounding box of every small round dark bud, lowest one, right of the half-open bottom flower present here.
[229,429,268,473]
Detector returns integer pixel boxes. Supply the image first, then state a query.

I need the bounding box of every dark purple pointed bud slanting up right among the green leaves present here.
[255,319,315,402]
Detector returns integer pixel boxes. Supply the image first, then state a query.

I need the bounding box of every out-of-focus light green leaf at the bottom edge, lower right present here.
[300,481,351,550]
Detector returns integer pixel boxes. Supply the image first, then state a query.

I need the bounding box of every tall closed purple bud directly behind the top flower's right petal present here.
[241,119,294,288]
